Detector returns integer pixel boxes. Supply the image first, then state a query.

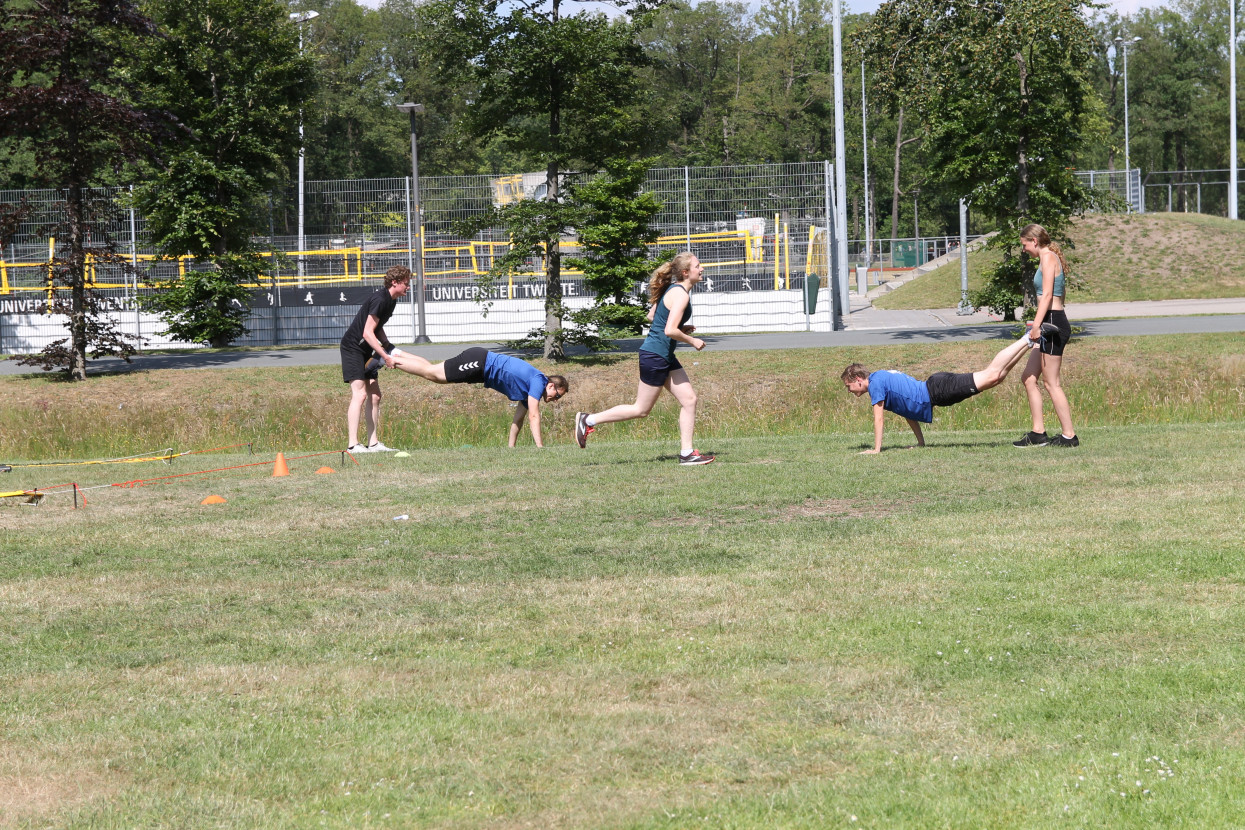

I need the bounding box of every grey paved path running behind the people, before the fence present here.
[0,294,1245,375]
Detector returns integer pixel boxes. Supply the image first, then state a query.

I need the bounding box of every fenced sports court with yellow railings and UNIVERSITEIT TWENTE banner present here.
[7,162,1165,353]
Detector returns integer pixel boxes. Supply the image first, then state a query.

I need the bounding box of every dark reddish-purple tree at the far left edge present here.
[0,0,171,381]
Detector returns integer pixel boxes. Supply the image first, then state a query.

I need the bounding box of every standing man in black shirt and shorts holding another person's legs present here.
[341,265,411,453]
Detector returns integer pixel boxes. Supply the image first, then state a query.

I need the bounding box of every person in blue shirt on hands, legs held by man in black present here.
[393,346,570,447]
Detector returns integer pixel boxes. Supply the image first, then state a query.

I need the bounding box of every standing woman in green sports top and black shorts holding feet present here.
[1013,225,1081,447]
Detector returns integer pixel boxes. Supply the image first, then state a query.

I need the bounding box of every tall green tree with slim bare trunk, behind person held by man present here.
[423,0,647,358]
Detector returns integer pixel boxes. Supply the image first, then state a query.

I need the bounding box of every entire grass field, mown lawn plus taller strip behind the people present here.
[7,336,1245,828]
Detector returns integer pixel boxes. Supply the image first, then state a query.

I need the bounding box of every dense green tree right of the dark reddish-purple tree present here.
[136,0,312,346]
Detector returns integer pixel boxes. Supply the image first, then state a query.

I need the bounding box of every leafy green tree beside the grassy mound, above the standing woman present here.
[867,0,1104,314]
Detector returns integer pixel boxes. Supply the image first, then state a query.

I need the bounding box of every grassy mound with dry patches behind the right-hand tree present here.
[874,213,1245,309]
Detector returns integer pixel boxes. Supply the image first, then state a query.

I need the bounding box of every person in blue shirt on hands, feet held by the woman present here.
[842,333,1033,455]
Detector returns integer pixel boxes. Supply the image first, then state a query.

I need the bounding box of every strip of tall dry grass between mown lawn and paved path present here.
[0,333,1245,459]
